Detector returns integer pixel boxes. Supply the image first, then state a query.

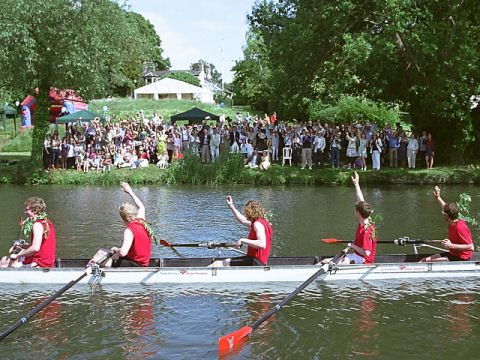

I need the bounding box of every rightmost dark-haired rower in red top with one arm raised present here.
[420,186,474,262]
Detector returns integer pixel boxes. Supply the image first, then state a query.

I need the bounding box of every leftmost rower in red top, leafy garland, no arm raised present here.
[0,197,56,268]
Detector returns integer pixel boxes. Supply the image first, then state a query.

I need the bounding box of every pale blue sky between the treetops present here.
[127,0,255,83]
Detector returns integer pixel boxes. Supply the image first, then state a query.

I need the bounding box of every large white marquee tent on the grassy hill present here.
[133,78,214,104]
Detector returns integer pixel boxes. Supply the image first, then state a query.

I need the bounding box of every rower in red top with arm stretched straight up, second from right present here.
[321,171,377,264]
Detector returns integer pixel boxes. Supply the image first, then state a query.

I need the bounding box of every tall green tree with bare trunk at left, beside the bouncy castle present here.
[0,0,168,164]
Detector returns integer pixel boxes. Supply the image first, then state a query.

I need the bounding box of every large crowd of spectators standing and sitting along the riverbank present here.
[43,111,435,173]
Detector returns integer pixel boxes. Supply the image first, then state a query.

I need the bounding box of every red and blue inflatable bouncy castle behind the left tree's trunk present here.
[21,87,88,128]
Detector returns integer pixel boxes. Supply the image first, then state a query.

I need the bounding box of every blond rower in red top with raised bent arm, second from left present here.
[89,182,152,267]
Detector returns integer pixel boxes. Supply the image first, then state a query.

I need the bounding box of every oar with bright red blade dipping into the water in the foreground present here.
[218,248,349,353]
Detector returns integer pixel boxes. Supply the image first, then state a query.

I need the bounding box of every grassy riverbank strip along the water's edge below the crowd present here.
[0,153,480,186]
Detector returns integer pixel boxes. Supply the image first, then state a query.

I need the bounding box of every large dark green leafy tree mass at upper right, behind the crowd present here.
[240,0,480,161]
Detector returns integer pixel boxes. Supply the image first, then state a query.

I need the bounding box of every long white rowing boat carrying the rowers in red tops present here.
[0,253,480,285]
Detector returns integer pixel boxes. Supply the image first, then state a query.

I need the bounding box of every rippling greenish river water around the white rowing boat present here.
[0,185,480,359]
